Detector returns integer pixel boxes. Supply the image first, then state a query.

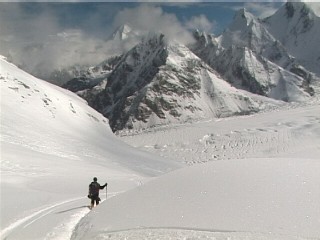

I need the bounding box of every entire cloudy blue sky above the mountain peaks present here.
[0,0,320,78]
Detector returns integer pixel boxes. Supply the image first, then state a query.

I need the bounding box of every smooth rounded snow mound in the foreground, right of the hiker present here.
[72,158,320,239]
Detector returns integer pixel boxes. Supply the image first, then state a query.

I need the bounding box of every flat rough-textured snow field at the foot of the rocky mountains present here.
[121,103,320,165]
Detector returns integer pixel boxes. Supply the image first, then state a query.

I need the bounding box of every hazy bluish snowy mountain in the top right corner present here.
[263,2,320,76]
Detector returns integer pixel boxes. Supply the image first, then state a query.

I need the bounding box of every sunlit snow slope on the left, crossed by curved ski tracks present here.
[0,57,178,239]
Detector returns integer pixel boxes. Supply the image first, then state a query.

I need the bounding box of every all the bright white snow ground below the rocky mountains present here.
[0,54,320,240]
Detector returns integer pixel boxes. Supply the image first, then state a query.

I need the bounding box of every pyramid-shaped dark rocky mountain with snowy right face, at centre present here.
[84,34,259,131]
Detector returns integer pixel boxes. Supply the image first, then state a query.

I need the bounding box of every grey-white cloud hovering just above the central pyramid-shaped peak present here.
[113,4,193,43]
